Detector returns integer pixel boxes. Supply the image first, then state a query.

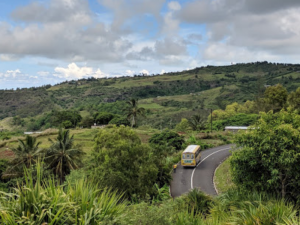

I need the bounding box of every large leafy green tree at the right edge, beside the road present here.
[230,111,300,198]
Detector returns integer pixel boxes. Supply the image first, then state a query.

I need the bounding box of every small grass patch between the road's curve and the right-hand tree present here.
[214,158,235,194]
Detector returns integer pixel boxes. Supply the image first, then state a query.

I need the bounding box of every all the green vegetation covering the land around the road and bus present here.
[0,62,300,225]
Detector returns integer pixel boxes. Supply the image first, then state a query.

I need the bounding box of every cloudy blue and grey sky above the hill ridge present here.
[0,0,300,89]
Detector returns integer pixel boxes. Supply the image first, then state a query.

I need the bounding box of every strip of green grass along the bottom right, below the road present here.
[121,190,300,225]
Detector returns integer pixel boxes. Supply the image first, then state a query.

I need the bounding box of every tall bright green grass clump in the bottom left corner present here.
[0,164,126,225]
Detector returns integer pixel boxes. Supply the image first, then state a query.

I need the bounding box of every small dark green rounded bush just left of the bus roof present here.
[149,130,184,150]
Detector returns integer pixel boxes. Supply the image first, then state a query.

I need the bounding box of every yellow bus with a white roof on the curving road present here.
[181,145,201,167]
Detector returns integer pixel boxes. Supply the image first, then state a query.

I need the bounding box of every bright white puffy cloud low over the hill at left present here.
[53,63,108,80]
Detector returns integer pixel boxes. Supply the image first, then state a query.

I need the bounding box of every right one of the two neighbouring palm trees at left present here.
[45,129,85,183]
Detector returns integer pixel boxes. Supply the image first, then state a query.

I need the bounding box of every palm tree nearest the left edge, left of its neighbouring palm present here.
[2,136,41,178]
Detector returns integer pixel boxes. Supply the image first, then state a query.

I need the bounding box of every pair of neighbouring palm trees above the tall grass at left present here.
[2,129,85,183]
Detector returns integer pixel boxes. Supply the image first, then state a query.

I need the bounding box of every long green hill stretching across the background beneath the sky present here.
[0,62,300,128]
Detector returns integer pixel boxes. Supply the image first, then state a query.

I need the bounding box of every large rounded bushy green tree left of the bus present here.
[89,126,158,199]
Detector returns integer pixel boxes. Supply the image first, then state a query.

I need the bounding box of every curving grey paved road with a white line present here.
[170,145,234,197]
